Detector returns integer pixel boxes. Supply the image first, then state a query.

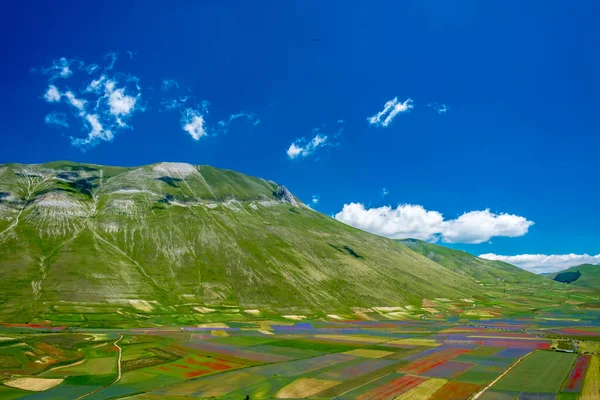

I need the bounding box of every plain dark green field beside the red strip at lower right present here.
[493,351,577,393]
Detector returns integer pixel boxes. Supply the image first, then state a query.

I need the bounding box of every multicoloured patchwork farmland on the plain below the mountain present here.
[0,316,600,400]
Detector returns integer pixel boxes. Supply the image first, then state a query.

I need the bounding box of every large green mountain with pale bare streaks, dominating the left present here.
[0,162,488,321]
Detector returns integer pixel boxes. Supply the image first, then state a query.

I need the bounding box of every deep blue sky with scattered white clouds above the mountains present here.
[0,1,600,270]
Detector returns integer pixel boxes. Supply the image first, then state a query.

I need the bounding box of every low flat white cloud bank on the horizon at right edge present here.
[479,253,600,274]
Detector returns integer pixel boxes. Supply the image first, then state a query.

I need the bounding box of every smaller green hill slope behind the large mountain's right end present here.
[400,239,545,284]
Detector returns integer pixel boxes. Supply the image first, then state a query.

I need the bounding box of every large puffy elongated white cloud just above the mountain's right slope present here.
[335,203,533,243]
